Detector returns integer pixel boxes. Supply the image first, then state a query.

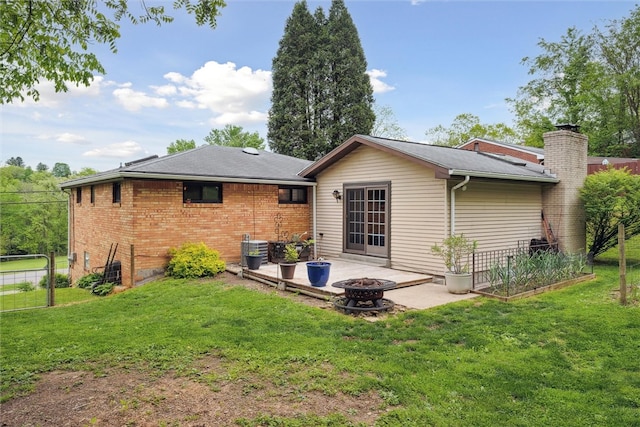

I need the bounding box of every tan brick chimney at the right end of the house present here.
[542,125,588,253]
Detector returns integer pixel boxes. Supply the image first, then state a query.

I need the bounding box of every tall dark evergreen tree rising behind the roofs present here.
[267,0,375,160]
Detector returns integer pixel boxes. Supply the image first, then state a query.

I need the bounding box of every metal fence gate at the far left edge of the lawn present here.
[0,254,66,311]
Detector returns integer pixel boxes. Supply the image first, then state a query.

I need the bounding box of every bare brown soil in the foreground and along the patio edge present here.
[0,273,392,427]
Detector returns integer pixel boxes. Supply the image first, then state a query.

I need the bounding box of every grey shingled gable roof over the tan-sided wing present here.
[301,135,558,183]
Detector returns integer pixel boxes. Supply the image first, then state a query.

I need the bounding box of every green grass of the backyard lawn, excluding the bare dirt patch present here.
[0,264,640,427]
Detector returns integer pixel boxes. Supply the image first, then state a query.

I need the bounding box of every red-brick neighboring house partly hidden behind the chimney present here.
[457,138,640,175]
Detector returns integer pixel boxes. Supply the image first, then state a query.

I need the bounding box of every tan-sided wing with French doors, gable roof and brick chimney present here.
[301,130,587,274]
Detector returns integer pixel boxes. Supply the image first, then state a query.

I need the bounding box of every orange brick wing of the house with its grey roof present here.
[61,145,315,285]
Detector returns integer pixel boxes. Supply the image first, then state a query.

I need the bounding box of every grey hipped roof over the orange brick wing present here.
[60,145,313,188]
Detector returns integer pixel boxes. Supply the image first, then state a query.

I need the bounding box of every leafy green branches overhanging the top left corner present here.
[0,0,225,104]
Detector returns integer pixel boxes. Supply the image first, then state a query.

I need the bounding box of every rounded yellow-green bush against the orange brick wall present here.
[166,243,226,279]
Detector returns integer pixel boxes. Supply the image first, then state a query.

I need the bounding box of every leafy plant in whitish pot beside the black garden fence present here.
[431,234,478,294]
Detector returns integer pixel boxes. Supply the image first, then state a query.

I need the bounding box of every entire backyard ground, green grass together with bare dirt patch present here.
[0,249,640,426]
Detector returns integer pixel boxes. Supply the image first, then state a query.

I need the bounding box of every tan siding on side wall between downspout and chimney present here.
[455,178,542,251]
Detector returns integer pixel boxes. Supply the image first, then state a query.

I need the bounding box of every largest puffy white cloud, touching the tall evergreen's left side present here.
[164,61,271,124]
